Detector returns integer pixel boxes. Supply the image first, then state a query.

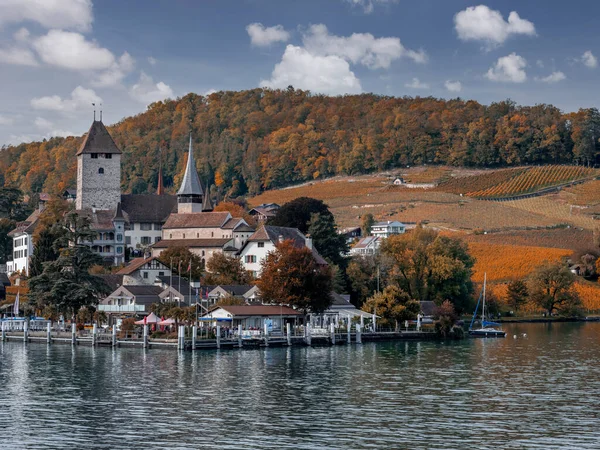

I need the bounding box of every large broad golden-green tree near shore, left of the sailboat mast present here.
[380,226,474,313]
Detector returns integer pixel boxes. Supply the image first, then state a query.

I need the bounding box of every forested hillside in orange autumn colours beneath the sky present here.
[0,88,600,197]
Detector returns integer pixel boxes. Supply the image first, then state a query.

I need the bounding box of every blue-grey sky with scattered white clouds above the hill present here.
[0,0,600,146]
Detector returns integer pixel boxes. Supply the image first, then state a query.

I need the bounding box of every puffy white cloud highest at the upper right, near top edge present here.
[454,5,535,47]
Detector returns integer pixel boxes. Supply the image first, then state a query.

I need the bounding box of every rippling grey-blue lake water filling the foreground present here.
[0,323,600,449]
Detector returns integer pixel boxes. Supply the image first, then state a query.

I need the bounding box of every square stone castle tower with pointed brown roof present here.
[75,120,121,210]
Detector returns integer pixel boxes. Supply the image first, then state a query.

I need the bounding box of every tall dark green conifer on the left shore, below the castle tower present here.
[29,213,110,317]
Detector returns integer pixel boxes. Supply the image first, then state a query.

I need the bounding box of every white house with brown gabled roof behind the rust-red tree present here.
[239,225,327,278]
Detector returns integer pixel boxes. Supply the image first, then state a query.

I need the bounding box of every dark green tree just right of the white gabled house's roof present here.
[308,214,348,267]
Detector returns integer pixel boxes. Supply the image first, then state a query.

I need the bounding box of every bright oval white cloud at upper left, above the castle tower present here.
[33,30,115,70]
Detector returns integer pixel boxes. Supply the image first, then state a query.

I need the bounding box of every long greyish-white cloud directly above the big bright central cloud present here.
[302,24,427,69]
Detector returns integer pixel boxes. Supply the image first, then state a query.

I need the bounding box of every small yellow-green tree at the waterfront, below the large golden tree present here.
[362,285,421,331]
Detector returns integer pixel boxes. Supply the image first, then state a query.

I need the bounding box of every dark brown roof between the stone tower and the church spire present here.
[121,194,177,223]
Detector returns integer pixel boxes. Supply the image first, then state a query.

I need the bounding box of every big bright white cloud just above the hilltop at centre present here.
[260,45,362,95]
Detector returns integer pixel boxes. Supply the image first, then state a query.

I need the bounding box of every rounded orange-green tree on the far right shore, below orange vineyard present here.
[529,261,581,315]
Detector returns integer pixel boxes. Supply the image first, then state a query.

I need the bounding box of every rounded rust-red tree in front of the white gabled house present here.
[256,240,333,314]
